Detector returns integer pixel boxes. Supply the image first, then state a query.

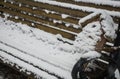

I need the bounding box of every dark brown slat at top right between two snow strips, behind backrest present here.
[55,0,120,23]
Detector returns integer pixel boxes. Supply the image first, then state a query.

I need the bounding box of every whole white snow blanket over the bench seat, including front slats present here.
[0,18,80,79]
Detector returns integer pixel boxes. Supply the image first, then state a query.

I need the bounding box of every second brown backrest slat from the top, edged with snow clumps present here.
[4,2,79,24]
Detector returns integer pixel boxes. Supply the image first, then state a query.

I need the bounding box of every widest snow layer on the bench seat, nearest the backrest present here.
[0,16,79,70]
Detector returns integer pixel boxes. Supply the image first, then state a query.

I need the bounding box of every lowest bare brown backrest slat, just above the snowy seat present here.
[0,10,76,40]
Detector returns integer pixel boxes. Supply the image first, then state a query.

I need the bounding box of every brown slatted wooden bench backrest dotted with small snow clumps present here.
[0,0,99,40]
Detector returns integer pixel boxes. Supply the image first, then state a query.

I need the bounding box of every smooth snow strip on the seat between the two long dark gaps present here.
[0,41,71,79]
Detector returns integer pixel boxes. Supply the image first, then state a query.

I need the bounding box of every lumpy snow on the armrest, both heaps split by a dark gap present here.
[74,12,118,53]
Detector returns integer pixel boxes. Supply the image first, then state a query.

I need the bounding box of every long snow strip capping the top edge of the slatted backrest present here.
[34,0,120,17]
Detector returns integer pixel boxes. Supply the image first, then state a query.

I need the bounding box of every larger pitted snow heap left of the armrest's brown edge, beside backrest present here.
[74,22,102,53]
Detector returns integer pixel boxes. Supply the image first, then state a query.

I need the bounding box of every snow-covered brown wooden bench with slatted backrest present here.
[0,0,117,79]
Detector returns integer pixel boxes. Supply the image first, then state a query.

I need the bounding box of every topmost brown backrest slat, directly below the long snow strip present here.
[15,0,90,17]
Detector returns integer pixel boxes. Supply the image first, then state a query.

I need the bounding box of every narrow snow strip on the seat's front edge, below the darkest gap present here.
[0,51,57,79]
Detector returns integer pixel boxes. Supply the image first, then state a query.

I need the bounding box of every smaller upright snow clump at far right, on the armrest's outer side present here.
[101,12,118,41]
